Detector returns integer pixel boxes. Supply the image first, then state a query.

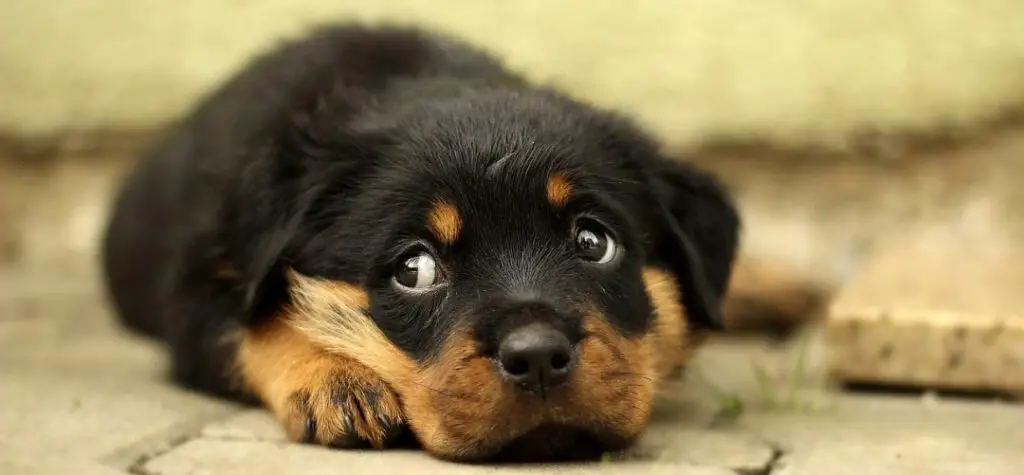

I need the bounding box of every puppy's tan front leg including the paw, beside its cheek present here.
[238,318,404,448]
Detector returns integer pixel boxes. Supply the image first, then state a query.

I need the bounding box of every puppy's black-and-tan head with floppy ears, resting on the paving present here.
[274,87,737,460]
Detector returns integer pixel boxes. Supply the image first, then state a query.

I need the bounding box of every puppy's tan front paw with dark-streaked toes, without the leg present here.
[279,361,406,448]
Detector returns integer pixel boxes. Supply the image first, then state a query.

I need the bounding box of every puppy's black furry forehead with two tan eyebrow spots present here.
[368,96,629,243]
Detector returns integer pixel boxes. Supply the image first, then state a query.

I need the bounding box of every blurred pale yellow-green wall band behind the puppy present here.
[6,0,1024,152]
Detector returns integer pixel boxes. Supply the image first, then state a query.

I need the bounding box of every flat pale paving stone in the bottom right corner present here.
[743,396,1024,475]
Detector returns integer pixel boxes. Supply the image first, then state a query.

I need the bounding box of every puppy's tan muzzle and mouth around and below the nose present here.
[387,313,657,462]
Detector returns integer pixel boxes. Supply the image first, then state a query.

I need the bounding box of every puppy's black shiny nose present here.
[498,325,572,395]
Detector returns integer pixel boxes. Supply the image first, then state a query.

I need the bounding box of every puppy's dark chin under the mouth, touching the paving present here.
[466,424,633,464]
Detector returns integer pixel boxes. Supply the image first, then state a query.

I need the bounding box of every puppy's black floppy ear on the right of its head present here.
[602,116,740,330]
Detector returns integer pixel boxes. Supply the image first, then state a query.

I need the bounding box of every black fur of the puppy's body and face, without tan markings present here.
[103,26,739,397]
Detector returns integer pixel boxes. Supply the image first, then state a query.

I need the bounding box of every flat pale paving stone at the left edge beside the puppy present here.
[0,279,238,466]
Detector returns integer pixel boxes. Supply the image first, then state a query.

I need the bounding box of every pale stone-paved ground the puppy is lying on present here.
[0,260,1024,475]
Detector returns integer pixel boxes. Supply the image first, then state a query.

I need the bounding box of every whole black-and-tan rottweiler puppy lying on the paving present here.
[103,25,739,461]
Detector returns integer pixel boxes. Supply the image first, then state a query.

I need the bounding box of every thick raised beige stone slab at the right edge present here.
[827,236,1024,396]
